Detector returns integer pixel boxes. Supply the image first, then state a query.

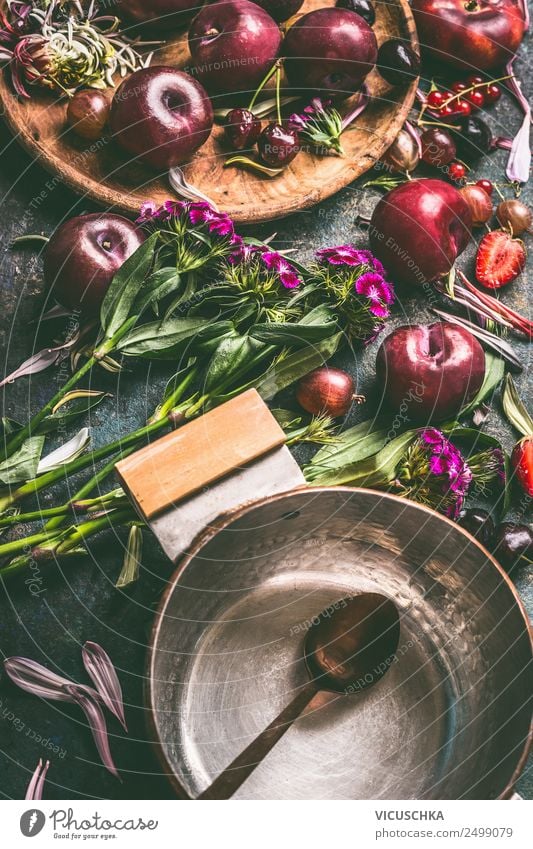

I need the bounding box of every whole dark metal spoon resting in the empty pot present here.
[198,593,400,799]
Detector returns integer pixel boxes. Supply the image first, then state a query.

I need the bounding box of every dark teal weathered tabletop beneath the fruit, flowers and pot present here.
[0,31,533,799]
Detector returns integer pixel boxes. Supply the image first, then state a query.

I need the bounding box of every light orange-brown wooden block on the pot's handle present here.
[116,389,285,519]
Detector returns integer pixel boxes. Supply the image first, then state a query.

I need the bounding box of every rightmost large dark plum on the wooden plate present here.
[283,8,378,97]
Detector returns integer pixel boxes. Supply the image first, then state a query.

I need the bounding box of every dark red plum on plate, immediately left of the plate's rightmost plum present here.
[189,0,281,94]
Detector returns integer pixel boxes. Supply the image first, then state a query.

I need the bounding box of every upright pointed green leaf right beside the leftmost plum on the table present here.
[100,233,159,339]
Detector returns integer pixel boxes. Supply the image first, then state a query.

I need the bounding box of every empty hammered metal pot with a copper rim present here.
[146,488,533,799]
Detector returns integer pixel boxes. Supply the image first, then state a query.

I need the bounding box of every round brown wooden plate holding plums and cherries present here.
[0,0,418,224]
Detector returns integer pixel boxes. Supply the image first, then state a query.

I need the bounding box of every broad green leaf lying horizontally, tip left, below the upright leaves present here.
[117,318,212,359]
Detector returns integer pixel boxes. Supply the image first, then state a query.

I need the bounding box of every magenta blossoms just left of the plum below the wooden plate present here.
[316,245,394,318]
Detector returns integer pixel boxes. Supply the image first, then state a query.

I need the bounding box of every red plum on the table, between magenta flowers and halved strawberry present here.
[369,179,472,285]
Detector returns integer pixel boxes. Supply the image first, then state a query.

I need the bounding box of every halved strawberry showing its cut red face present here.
[476,230,526,289]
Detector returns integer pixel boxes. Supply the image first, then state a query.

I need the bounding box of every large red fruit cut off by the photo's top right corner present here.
[411,0,525,72]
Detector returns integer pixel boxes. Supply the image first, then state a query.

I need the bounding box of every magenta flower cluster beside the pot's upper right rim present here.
[419,427,474,519]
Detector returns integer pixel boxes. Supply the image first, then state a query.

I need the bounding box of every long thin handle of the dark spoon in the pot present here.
[198,681,318,799]
